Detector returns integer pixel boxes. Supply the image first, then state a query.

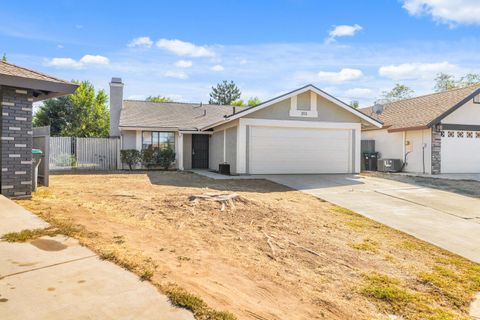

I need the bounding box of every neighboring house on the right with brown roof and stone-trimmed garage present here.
[360,84,480,174]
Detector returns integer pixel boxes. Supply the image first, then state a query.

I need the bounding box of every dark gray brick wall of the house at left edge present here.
[0,86,33,197]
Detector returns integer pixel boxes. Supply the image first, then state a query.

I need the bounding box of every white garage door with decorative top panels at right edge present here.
[440,130,480,173]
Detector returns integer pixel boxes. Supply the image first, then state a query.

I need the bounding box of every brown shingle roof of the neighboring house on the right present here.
[359,84,480,131]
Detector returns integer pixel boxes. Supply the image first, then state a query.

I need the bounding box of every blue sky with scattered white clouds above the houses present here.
[0,0,480,106]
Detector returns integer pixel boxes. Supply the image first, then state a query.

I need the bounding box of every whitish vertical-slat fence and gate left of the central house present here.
[49,137,121,171]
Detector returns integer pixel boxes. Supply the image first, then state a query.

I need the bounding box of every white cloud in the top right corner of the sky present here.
[403,0,480,25]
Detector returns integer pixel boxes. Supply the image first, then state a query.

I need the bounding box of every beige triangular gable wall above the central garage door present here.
[245,91,361,123]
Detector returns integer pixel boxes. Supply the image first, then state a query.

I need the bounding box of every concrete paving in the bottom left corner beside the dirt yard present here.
[0,196,194,320]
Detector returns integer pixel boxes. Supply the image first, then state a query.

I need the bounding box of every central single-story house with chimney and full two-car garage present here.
[110,78,382,174]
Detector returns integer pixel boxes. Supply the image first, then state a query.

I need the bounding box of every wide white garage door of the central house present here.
[248,127,352,174]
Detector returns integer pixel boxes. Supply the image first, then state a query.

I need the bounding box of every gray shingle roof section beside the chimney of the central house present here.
[120,100,243,130]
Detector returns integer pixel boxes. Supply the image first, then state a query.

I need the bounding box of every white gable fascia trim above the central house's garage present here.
[201,85,383,130]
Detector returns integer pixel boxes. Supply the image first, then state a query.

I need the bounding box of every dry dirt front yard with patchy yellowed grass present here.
[14,172,480,320]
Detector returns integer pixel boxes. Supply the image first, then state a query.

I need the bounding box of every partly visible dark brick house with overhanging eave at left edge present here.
[0,61,77,197]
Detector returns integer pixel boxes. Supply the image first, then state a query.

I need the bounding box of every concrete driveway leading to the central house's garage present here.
[265,175,480,263]
